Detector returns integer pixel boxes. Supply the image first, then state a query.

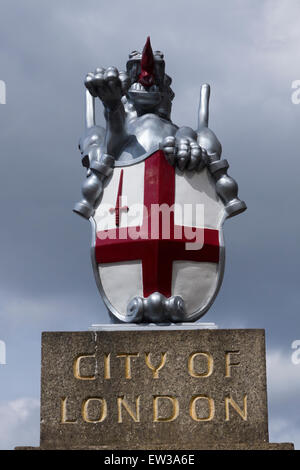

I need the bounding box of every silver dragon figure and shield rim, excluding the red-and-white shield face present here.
[74,41,246,323]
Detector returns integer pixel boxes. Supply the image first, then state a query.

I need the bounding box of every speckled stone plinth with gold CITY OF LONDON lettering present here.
[34,327,293,450]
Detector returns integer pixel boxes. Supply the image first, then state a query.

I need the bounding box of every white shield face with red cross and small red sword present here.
[92,151,226,321]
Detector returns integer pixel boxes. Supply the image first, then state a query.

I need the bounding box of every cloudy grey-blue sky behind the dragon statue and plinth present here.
[0,0,300,449]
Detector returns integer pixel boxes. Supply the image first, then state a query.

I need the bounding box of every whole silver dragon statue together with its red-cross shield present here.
[74,37,246,323]
